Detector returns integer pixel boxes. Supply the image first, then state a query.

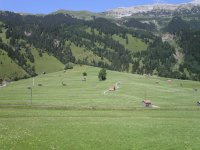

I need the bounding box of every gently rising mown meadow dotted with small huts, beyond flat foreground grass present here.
[0,66,200,106]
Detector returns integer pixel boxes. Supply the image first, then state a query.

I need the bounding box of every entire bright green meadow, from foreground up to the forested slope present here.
[0,66,200,150]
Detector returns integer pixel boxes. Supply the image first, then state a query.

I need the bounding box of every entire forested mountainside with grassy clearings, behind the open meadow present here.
[0,12,200,80]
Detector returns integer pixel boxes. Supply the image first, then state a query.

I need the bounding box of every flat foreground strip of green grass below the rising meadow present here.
[0,107,200,150]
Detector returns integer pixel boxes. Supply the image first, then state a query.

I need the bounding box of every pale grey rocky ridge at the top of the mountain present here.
[106,0,200,18]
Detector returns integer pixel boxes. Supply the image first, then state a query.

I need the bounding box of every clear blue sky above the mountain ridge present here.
[0,0,195,14]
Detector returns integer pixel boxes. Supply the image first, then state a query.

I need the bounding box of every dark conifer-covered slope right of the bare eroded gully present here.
[164,16,200,80]
